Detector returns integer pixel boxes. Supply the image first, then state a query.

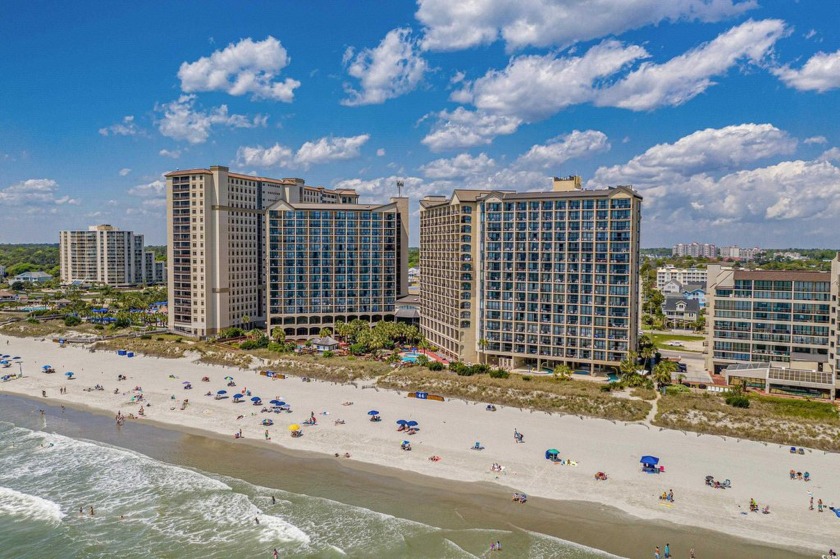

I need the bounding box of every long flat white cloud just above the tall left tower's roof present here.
[236,134,370,169]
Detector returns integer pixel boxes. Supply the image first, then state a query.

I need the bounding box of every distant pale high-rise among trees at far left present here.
[59,225,166,287]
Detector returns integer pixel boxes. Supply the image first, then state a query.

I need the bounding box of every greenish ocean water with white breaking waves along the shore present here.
[0,398,614,559]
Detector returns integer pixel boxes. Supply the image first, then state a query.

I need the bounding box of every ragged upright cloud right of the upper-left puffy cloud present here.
[341,28,428,106]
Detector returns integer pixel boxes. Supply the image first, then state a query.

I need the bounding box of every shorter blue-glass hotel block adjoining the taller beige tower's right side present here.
[265,195,408,339]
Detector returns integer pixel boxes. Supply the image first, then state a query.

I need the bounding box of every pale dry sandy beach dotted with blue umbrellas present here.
[0,336,840,554]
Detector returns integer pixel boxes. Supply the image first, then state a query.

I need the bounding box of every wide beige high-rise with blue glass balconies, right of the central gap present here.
[420,176,642,371]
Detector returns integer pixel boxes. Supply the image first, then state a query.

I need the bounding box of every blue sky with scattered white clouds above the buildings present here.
[0,0,840,247]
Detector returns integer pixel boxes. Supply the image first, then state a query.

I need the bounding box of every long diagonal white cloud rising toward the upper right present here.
[595,19,788,111]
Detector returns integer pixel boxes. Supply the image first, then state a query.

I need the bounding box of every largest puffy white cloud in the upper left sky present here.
[178,36,300,103]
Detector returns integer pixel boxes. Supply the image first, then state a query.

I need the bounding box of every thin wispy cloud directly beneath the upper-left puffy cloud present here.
[155,95,268,144]
